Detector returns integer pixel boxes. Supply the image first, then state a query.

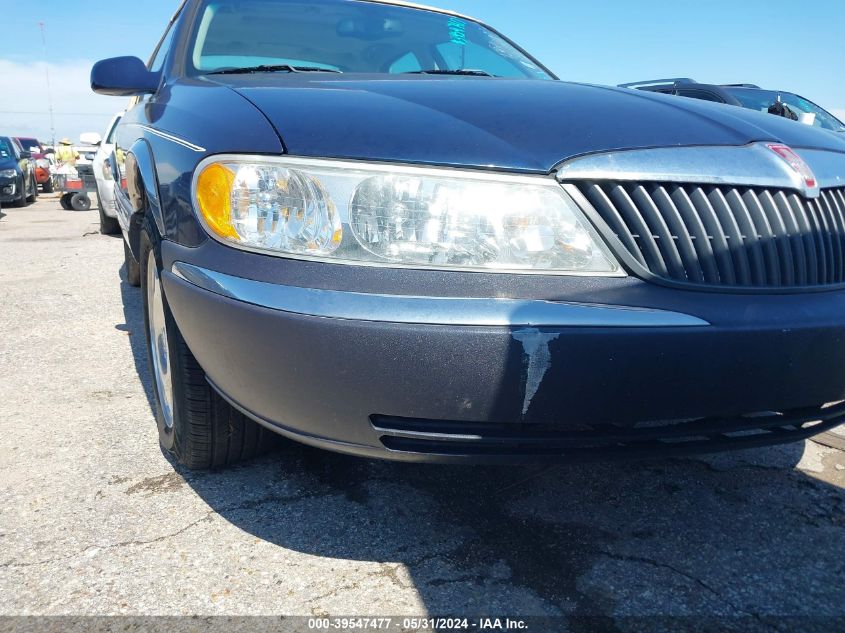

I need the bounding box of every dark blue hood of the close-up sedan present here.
[213,73,845,173]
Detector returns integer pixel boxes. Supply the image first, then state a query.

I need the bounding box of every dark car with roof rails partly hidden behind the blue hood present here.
[619,78,845,133]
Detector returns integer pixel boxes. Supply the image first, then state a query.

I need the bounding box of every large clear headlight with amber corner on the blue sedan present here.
[194,156,620,274]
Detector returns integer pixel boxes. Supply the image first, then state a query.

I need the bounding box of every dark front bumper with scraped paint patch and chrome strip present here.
[163,242,845,462]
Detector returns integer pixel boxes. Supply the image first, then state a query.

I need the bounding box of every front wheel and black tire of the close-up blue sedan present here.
[140,216,271,469]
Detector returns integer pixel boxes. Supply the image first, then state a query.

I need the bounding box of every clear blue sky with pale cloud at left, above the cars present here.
[0,0,845,138]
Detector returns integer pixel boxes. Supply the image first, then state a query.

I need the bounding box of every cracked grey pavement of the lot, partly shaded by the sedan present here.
[0,196,845,630]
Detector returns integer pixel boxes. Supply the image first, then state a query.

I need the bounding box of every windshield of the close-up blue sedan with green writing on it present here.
[190,0,551,79]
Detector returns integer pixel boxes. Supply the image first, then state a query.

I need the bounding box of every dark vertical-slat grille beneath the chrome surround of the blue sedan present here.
[571,181,845,288]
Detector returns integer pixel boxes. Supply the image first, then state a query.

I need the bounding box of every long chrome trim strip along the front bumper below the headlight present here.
[171,262,710,328]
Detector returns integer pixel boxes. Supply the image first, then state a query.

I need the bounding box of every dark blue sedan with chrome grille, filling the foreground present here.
[92,0,845,468]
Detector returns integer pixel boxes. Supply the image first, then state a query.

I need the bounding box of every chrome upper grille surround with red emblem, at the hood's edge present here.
[556,143,845,198]
